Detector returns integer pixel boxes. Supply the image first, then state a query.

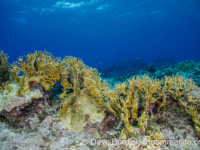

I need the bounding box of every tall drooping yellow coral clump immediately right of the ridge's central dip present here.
[107,76,161,132]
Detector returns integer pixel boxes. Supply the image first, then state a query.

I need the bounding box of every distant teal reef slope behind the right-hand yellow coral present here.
[101,58,200,86]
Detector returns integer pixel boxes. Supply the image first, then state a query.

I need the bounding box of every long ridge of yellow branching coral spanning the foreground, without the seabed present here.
[0,51,200,149]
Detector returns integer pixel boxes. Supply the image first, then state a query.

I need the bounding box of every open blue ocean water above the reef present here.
[0,0,200,68]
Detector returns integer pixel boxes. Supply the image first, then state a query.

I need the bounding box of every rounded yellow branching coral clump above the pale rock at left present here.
[10,51,63,93]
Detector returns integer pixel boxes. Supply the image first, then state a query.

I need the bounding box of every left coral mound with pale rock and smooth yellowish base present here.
[1,51,111,130]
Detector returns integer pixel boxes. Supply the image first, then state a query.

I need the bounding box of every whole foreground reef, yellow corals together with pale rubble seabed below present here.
[0,51,200,149]
